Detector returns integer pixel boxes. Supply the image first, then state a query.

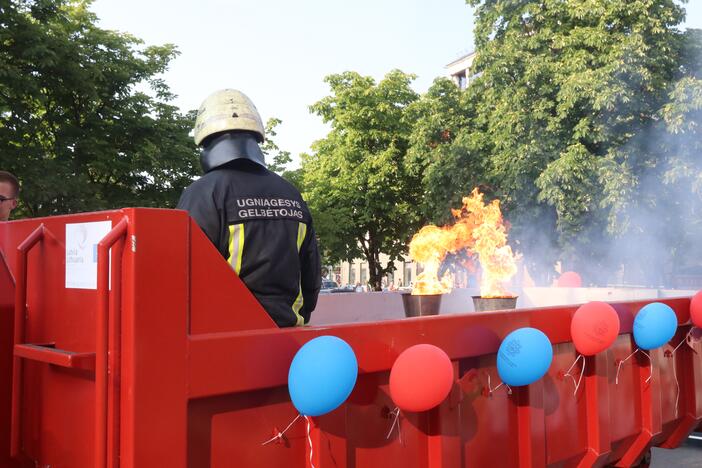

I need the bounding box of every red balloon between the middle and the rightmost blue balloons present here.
[570,301,619,356]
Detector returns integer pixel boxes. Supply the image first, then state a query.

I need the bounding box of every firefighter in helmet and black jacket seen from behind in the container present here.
[178,89,321,327]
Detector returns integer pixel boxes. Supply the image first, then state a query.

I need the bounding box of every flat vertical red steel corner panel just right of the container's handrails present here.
[120,209,189,468]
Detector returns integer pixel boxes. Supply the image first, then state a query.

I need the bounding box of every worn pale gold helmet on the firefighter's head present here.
[193,89,265,146]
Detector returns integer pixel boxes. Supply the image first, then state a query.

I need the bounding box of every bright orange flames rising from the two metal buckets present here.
[409,188,517,297]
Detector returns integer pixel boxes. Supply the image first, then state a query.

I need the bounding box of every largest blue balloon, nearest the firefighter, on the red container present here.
[288,336,358,416]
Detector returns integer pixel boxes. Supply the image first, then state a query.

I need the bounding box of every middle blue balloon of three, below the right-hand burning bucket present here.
[497,327,553,386]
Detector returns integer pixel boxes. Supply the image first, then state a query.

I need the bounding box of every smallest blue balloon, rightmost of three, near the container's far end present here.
[634,302,678,349]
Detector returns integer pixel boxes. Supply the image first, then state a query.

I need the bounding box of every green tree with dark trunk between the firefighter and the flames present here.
[302,70,422,290]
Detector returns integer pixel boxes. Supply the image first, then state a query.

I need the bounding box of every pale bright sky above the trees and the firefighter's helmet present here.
[92,0,702,167]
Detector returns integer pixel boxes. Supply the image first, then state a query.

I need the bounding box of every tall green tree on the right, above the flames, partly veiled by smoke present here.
[413,0,694,284]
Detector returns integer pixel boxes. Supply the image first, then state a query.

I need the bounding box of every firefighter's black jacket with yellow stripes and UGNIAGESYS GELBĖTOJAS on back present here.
[178,159,321,327]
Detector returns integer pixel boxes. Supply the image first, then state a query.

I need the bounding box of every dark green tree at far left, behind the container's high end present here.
[0,0,198,216]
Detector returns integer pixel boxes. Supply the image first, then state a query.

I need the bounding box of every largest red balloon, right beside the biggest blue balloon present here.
[390,344,453,411]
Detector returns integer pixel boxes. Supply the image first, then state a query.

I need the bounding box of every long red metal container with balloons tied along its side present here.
[0,209,702,468]
